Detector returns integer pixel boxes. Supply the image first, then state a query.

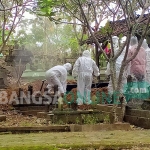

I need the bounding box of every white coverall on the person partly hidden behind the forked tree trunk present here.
[105,36,127,94]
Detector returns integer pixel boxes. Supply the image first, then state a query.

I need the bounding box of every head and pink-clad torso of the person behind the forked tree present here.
[127,37,146,82]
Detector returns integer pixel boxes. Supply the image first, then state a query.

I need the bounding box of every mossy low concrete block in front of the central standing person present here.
[46,110,106,124]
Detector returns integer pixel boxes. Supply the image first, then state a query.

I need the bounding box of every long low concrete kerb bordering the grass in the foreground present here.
[0,123,131,133]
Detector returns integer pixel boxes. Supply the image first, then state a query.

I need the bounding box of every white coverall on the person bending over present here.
[45,63,72,95]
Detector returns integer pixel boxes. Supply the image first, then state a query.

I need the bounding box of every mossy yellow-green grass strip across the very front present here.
[0,130,150,150]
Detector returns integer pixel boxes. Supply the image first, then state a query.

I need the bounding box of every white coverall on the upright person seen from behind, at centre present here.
[72,50,100,105]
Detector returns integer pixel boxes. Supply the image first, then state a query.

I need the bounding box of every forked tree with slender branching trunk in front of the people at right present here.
[36,0,150,121]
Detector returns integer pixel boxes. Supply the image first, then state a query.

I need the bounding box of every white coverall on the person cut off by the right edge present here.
[142,39,150,84]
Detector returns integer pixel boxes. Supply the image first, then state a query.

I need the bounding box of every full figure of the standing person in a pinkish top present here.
[126,36,146,109]
